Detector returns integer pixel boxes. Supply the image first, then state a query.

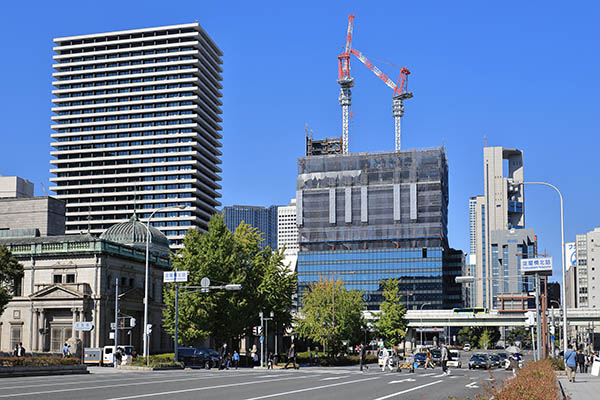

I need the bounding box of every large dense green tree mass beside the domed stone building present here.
[163,214,296,345]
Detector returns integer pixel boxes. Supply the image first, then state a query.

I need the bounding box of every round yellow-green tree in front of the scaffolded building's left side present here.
[296,279,365,356]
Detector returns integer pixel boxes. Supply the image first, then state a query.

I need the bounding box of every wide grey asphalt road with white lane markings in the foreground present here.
[0,361,510,400]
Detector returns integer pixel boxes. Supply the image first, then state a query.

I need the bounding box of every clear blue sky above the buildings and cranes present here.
[0,0,600,278]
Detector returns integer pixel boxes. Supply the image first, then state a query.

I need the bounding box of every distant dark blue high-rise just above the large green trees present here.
[223,206,278,250]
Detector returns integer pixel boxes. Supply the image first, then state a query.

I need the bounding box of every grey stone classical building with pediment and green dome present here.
[0,214,173,354]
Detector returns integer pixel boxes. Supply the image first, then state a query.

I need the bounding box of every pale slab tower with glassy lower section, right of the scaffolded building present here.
[469,147,536,308]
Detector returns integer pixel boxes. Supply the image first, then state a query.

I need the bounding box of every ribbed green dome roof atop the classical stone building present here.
[100,212,169,254]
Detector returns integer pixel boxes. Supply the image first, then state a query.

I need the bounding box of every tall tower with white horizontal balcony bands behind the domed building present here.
[51,23,223,247]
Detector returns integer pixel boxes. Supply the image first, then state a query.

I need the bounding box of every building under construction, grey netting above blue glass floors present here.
[296,147,464,310]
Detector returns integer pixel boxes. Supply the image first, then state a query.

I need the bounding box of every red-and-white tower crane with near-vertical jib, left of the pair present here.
[338,14,354,154]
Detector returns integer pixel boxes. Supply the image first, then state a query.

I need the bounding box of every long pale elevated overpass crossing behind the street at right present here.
[406,308,600,328]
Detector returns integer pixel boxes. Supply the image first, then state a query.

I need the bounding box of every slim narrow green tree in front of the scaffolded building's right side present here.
[375,279,406,347]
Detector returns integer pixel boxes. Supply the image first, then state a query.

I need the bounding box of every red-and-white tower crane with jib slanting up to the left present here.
[352,49,413,151]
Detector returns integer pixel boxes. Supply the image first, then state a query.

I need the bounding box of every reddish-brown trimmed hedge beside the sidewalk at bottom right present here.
[478,360,561,400]
